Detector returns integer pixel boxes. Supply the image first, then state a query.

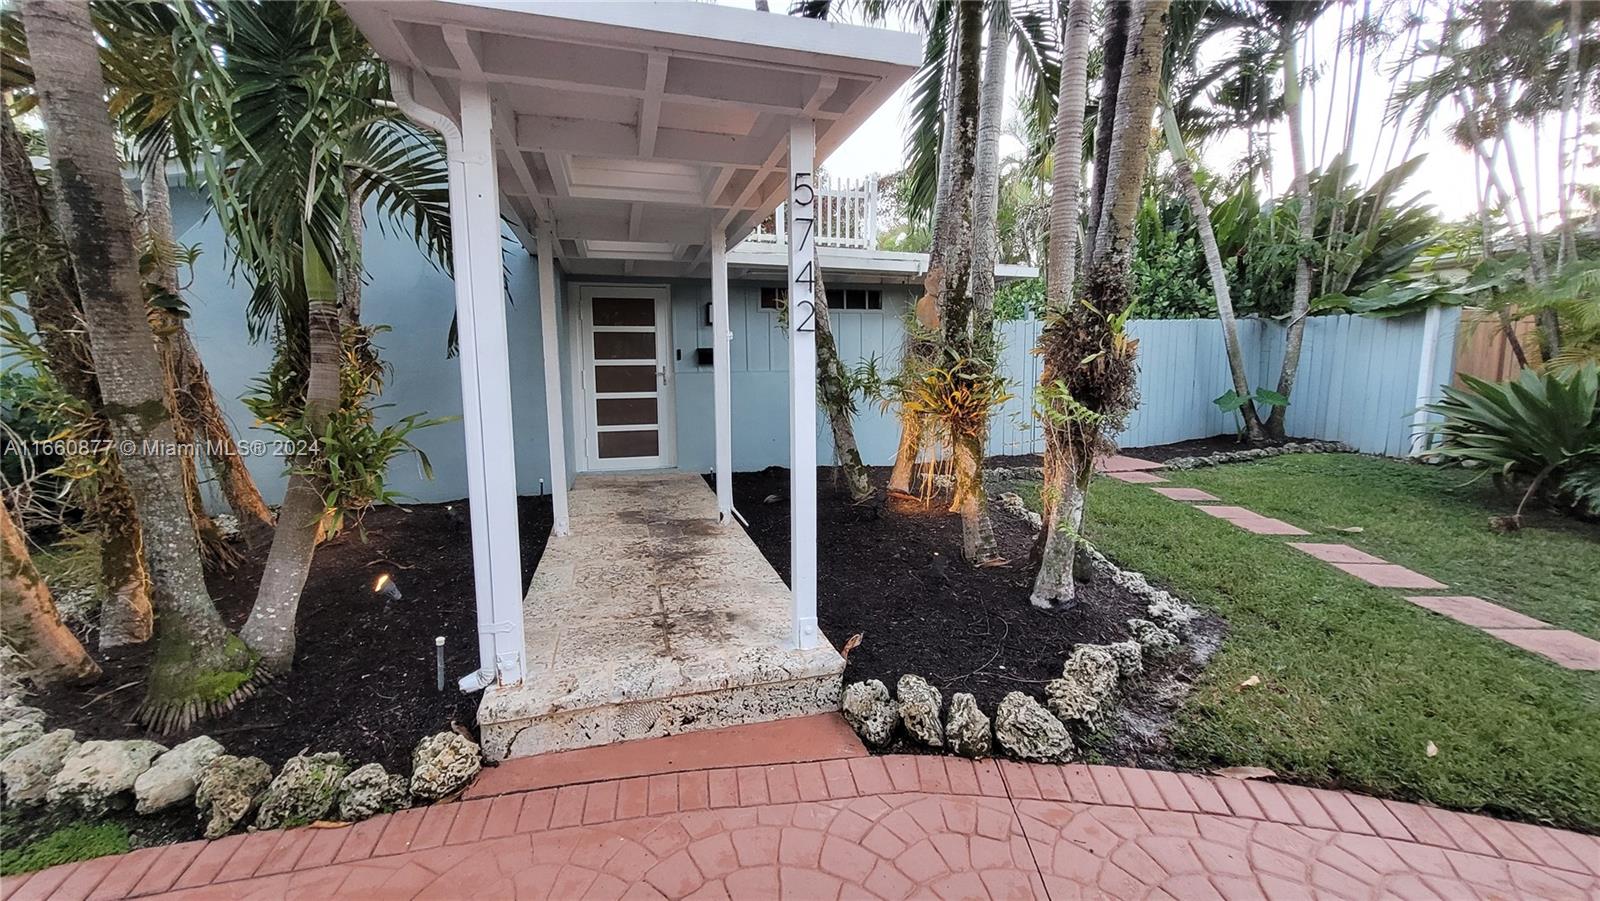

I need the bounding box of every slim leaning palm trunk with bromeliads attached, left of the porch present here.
[238,242,341,672]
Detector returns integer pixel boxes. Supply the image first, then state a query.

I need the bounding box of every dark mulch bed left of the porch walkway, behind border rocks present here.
[29,498,550,773]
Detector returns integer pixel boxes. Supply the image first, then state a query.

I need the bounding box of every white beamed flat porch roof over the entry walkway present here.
[346,0,922,277]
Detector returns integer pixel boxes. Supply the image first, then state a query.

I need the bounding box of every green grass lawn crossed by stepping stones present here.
[1017,455,1600,832]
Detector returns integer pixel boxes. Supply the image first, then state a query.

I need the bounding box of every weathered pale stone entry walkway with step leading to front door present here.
[478,472,845,760]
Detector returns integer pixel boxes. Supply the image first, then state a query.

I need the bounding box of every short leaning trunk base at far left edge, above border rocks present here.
[0,503,101,685]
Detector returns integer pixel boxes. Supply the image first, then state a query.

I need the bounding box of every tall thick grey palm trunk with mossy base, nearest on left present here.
[21,0,256,730]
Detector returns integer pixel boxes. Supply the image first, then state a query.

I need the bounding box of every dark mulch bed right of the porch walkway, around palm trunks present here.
[733,461,1221,762]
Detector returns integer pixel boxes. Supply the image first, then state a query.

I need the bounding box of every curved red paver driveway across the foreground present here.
[0,717,1600,901]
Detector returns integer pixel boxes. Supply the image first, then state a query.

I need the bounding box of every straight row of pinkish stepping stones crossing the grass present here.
[1104,458,1600,671]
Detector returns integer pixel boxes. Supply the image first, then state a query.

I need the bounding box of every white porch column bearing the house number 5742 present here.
[789,118,821,650]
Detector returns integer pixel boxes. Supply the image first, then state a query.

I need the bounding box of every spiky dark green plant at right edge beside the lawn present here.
[1424,363,1600,528]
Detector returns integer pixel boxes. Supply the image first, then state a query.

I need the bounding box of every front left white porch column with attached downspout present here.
[450,82,528,690]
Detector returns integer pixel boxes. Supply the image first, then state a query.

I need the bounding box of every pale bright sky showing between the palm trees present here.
[718,0,1600,222]
